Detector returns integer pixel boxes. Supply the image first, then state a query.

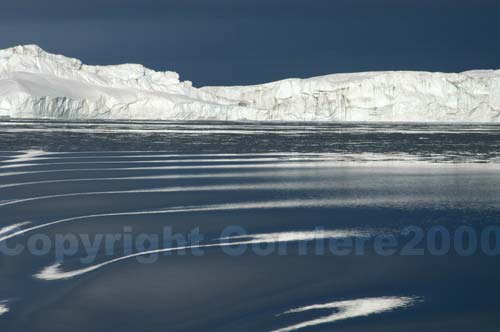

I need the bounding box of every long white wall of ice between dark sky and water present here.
[0,45,500,123]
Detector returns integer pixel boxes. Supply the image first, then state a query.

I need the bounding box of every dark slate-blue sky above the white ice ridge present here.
[0,0,500,86]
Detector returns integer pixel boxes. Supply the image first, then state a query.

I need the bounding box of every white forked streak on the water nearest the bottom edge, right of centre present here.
[273,297,418,332]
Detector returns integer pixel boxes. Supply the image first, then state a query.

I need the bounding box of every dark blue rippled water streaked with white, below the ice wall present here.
[0,121,500,331]
